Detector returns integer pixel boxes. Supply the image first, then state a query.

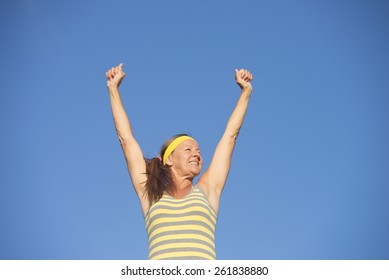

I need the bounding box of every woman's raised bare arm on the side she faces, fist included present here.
[198,69,253,212]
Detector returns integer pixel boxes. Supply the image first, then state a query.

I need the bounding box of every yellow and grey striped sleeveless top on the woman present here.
[145,185,217,260]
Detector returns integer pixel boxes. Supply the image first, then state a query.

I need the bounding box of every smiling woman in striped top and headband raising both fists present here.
[106,64,252,260]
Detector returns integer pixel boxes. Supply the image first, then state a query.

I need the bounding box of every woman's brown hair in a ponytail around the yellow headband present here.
[145,134,189,205]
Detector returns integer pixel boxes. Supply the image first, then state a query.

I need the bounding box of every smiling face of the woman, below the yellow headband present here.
[171,139,203,178]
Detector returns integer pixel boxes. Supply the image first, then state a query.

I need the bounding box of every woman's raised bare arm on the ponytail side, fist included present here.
[106,64,149,214]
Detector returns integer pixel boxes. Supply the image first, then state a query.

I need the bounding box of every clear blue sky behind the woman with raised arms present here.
[0,0,389,259]
